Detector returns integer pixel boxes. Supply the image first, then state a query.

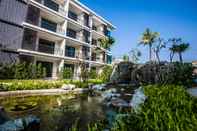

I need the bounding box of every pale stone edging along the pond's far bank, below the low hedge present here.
[0,88,89,98]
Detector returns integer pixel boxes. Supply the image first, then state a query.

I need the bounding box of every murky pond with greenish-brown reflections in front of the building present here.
[0,94,111,131]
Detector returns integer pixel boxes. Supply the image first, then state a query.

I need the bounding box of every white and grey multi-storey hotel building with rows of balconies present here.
[0,0,115,79]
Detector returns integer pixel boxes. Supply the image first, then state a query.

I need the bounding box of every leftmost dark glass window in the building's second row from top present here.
[41,18,57,32]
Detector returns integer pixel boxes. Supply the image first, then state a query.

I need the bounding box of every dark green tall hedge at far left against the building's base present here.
[0,63,46,79]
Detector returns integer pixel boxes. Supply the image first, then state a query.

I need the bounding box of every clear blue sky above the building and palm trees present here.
[80,0,197,62]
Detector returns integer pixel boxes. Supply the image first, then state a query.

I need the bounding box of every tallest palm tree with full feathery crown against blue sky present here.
[140,28,159,61]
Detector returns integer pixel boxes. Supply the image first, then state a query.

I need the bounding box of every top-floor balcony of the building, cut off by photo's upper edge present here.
[32,0,67,16]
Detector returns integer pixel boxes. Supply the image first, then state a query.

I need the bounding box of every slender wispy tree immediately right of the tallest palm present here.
[153,38,166,63]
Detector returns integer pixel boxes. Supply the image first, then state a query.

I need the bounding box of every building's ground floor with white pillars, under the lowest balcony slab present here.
[19,54,104,80]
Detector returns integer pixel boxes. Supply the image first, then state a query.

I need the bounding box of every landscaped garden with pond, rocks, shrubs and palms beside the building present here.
[0,29,197,131]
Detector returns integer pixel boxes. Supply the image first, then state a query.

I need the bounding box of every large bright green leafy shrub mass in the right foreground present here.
[113,85,197,131]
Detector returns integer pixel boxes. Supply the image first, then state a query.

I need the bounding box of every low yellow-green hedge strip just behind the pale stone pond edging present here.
[0,80,63,91]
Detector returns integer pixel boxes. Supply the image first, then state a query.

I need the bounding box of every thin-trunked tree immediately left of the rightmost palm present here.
[168,38,182,62]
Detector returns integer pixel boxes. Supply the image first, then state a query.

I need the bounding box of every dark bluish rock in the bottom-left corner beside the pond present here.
[0,116,40,131]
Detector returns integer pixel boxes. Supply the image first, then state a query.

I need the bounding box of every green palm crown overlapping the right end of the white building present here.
[98,36,115,49]
